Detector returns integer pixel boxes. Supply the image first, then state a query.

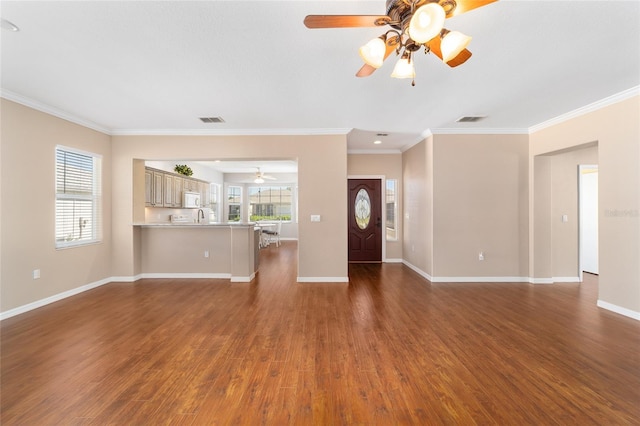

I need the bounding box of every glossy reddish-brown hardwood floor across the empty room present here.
[0,242,640,425]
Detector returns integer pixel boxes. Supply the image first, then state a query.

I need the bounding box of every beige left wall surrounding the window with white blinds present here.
[0,99,111,312]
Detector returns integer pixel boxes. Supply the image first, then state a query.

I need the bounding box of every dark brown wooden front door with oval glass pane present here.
[349,179,382,262]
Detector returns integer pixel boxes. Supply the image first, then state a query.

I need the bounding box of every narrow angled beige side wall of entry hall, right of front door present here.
[402,137,433,276]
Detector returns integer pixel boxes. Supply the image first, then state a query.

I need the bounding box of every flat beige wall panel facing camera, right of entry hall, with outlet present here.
[432,135,529,280]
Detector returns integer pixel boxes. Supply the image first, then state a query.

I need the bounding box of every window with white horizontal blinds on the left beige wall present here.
[56,147,102,248]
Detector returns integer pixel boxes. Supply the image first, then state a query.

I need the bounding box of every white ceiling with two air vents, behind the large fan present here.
[0,0,640,152]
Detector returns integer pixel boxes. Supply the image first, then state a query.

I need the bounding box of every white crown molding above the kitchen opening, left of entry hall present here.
[111,128,352,136]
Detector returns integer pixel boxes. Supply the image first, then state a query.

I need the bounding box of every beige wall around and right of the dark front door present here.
[347,154,402,259]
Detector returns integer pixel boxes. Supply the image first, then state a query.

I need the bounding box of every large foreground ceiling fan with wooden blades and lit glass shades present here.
[304,0,497,86]
